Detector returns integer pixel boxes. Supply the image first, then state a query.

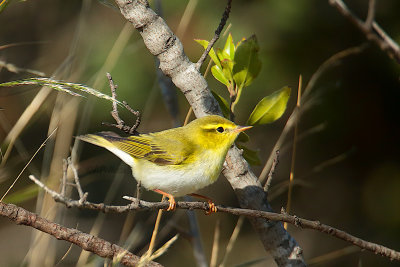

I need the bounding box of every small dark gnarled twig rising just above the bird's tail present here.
[103,72,140,135]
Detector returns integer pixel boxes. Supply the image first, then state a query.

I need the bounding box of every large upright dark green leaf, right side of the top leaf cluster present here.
[232,35,261,89]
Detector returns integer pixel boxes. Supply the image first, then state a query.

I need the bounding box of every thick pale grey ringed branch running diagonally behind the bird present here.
[115,0,305,266]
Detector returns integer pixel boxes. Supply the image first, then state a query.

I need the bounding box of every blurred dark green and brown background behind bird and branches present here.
[0,0,400,266]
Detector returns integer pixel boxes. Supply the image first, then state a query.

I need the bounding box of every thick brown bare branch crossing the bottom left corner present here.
[0,202,162,267]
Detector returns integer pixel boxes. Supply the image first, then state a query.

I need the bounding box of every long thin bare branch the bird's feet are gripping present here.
[29,175,400,261]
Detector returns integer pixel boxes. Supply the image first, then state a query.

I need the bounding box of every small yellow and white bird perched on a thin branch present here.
[77,115,252,211]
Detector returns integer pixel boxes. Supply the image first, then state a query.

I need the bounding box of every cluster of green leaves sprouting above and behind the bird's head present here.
[196,34,291,165]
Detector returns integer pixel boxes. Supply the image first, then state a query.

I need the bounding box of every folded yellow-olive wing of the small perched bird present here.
[85,133,191,165]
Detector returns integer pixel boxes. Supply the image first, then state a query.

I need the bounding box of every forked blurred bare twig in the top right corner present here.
[329,0,400,63]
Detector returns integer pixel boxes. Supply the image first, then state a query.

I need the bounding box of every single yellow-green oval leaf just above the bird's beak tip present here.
[247,86,290,125]
